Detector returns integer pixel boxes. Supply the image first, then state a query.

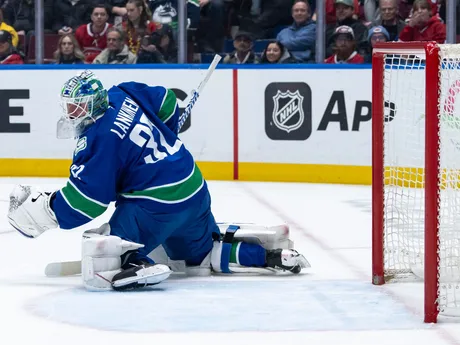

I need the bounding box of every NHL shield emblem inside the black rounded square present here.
[273,90,305,133]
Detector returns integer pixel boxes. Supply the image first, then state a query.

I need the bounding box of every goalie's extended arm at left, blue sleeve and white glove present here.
[8,129,120,238]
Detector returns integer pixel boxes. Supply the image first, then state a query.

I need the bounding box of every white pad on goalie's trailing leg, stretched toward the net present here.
[217,223,294,249]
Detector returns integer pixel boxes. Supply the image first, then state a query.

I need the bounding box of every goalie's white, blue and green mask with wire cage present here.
[57,70,109,139]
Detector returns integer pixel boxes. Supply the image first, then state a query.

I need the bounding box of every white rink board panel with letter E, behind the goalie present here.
[0,68,233,162]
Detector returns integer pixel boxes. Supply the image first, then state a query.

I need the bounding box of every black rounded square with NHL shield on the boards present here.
[265,82,312,140]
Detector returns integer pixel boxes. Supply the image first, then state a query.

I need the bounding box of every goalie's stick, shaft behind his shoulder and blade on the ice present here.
[45,54,222,277]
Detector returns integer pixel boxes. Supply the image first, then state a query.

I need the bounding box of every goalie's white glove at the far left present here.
[8,185,58,238]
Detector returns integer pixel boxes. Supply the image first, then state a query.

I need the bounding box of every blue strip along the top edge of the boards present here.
[0,64,372,70]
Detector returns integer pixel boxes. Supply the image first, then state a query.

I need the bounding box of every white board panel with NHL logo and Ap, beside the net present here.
[238,69,372,166]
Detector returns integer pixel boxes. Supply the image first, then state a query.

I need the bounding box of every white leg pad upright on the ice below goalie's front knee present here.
[81,224,144,291]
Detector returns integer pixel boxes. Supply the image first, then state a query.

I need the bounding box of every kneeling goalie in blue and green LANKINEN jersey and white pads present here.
[8,71,310,291]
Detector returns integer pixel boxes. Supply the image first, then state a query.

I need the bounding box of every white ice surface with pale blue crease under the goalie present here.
[0,178,460,345]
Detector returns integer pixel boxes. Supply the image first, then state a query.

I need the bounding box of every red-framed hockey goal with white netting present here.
[372,42,460,322]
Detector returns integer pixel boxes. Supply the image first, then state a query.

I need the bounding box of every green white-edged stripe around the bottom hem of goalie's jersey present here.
[122,164,204,204]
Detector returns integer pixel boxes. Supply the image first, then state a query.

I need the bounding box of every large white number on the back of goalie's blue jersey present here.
[129,114,182,164]
